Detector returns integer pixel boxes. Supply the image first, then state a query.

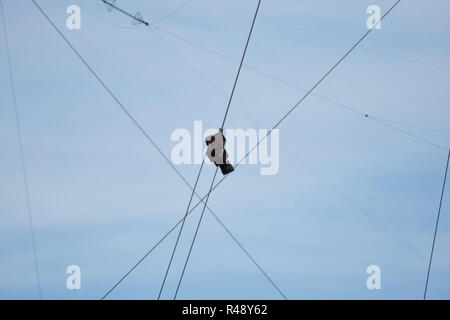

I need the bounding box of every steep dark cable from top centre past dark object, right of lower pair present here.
[163,0,261,300]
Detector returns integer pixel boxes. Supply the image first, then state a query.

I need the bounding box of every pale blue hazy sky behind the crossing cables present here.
[0,0,450,299]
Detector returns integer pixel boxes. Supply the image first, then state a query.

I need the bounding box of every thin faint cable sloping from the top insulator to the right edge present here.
[153,26,447,151]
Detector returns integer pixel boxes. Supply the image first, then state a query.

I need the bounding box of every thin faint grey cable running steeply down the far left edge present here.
[0,0,42,300]
